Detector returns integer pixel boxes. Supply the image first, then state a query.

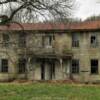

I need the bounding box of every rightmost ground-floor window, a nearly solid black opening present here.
[91,59,98,74]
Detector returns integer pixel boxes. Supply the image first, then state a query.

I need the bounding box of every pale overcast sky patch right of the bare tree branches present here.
[74,0,100,20]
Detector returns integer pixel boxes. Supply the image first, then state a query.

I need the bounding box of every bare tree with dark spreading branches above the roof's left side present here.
[0,0,74,23]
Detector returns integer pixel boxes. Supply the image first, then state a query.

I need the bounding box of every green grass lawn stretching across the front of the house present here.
[0,83,100,100]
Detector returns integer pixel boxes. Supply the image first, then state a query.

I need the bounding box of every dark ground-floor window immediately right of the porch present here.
[71,59,79,74]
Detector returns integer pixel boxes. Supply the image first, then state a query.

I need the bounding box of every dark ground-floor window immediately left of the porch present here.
[18,59,26,73]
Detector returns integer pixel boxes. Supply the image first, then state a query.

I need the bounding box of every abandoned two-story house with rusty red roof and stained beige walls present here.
[0,21,100,82]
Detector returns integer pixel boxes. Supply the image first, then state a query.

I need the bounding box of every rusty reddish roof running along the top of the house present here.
[0,21,100,31]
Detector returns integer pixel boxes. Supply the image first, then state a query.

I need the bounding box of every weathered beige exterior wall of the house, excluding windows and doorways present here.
[0,31,100,82]
